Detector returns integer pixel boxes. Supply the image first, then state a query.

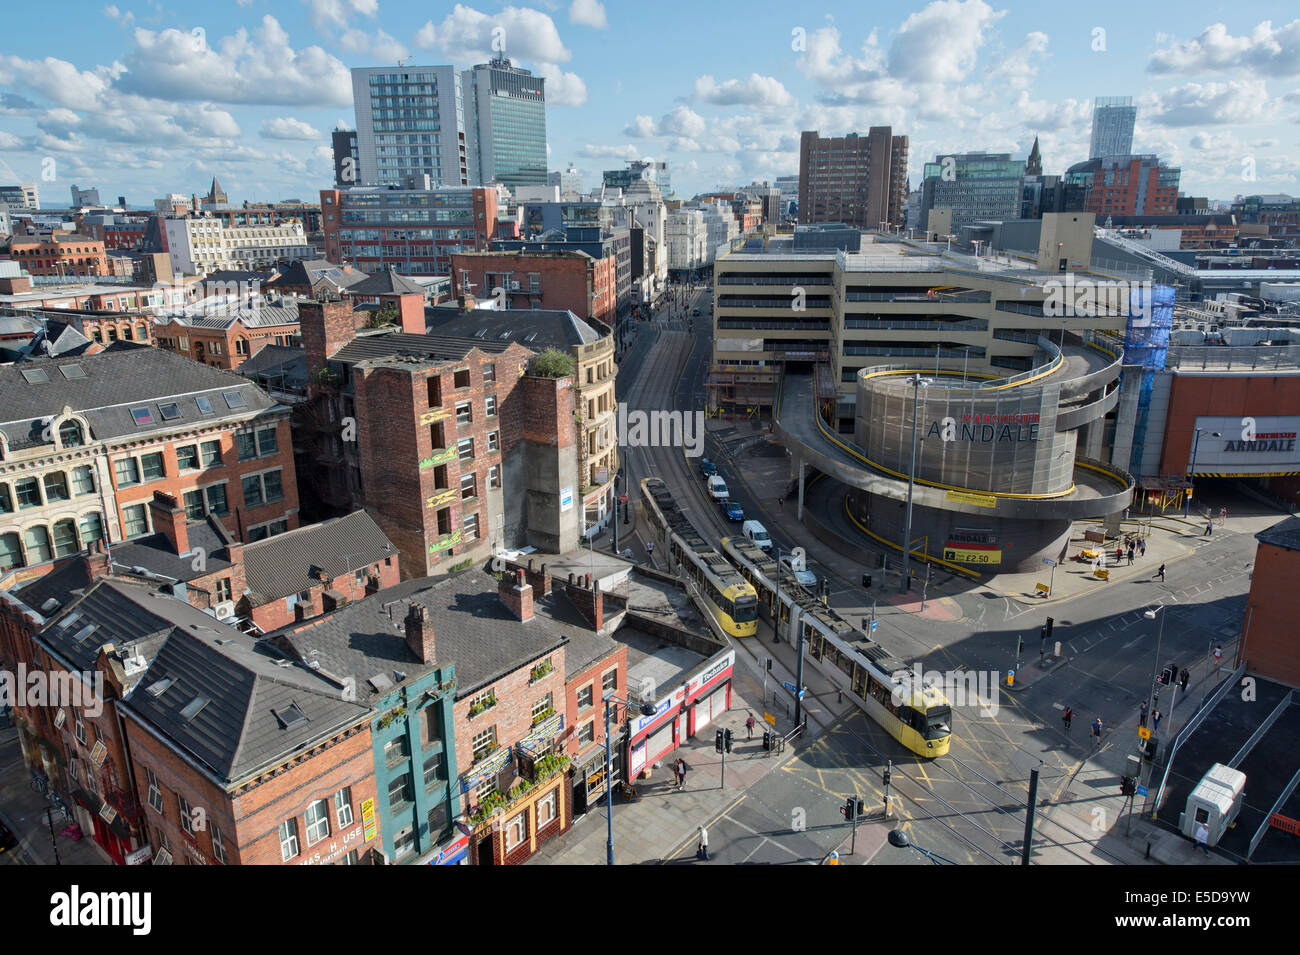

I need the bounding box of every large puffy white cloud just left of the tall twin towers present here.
[118,16,352,107]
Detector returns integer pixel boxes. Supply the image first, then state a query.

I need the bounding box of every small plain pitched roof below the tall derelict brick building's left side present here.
[243,511,397,605]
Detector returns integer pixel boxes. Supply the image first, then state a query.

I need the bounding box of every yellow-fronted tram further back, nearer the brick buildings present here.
[641,478,758,637]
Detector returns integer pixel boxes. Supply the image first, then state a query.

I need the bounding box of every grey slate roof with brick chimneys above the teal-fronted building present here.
[270,568,590,700]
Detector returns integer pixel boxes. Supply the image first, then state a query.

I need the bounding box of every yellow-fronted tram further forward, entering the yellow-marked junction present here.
[722,537,953,758]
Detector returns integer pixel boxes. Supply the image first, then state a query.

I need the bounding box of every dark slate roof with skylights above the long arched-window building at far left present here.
[0,342,276,448]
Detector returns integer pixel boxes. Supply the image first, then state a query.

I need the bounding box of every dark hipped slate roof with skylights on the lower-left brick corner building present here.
[111,581,369,785]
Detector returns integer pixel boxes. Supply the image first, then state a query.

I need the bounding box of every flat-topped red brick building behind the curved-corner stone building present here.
[451,252,618,326]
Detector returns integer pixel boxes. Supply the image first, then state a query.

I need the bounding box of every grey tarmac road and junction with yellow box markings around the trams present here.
[619,280,1255,864]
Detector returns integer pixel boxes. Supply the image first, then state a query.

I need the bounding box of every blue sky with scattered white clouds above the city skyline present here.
[0,0,1300,205]
